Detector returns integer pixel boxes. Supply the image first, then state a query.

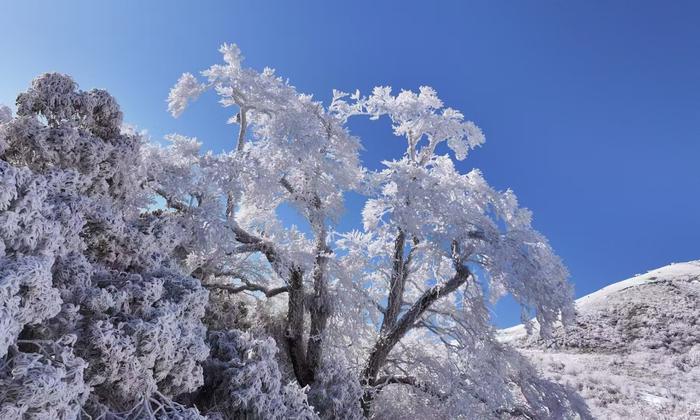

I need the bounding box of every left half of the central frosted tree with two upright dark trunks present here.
[159,45,364,394]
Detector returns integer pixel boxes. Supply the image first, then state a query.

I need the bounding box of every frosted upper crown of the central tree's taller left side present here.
[168,44,363,233]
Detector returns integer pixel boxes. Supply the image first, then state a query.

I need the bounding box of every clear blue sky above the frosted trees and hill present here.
[0,0,700,326]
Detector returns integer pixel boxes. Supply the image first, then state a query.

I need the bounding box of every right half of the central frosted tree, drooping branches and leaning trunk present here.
[331,73,576,418]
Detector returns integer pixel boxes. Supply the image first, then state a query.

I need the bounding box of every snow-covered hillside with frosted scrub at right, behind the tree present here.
[499,260,700,419]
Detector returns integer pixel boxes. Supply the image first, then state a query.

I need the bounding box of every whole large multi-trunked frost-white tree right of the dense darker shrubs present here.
[165,45,587,418]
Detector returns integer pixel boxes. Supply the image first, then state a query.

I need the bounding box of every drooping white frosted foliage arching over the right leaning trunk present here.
[350,156,573,334]
